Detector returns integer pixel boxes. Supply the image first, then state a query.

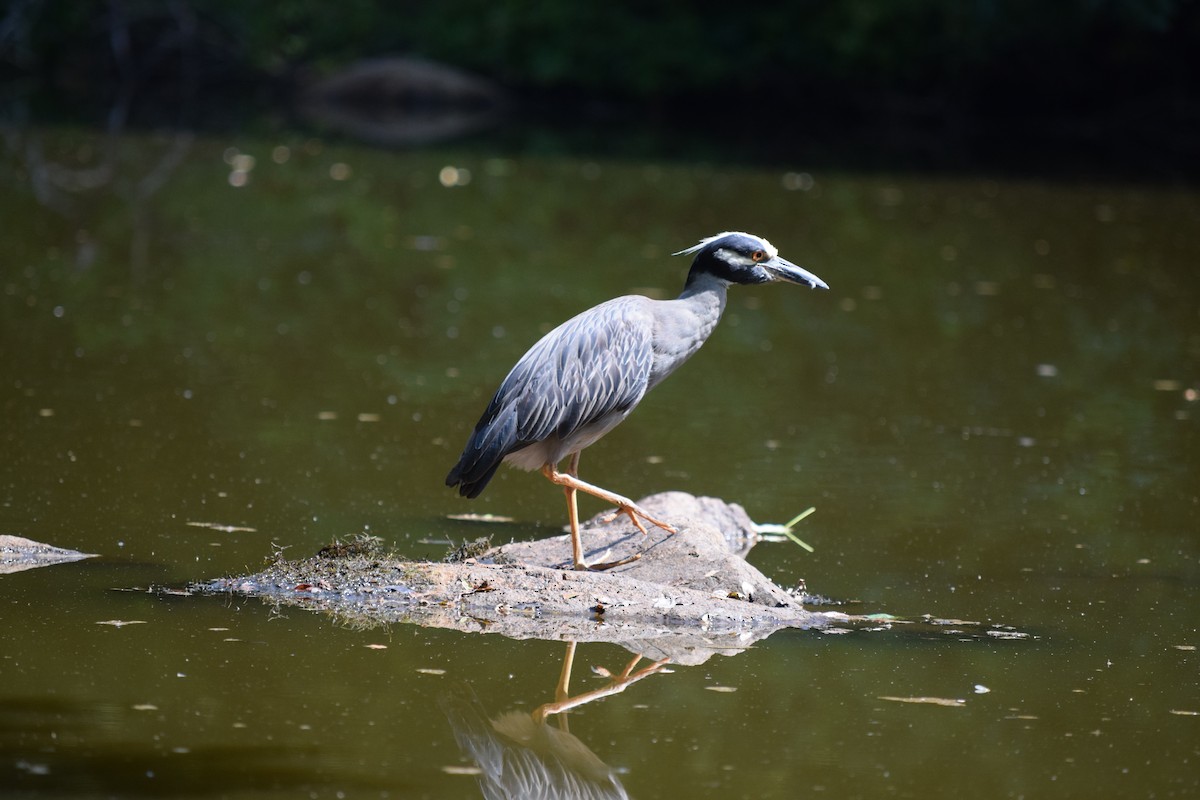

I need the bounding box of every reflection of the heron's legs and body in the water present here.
[439,642,670,800]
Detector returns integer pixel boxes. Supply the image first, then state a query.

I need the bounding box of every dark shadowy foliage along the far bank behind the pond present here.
[9,0,1200,127]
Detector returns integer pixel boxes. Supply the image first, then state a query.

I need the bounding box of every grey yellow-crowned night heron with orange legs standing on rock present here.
[446,233,829,570]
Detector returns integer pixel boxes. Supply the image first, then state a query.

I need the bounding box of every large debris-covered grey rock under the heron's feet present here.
[204,492,827,664]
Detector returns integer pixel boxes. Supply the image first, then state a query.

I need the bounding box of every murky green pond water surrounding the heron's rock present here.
[0,130,1200,799]
